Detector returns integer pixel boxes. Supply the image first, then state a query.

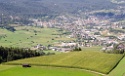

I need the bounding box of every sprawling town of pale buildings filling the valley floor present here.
[28,15,125,52]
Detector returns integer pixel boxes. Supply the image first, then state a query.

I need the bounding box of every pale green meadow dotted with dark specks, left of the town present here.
[0,26,74,48]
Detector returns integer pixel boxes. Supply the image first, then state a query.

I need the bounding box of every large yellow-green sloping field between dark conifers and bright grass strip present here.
[7,48,122,73]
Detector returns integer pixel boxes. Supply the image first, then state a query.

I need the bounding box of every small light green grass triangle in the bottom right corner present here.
[109,58,125,76]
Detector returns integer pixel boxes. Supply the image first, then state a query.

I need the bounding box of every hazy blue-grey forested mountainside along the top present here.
[0,0,117,16]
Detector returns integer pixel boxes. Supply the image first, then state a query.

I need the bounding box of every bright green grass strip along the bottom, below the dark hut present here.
[0,65,100,76]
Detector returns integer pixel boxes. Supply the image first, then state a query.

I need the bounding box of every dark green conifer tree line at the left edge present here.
[0,46,45,63]
